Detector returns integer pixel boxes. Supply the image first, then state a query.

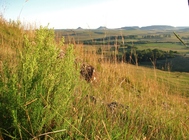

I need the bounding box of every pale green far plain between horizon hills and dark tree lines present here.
[55,29,189,43]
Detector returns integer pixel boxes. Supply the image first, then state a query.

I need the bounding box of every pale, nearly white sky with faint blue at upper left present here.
[0,0,189,29]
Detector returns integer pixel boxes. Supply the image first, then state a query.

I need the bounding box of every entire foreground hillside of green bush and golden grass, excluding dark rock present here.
[0,17,189,140]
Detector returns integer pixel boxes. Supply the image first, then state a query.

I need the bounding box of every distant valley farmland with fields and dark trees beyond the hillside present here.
[55,29,189,72]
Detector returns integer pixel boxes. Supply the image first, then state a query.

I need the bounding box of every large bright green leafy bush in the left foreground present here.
[0,27,79,139]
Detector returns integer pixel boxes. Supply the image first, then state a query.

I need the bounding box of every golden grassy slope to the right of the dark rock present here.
[74,47,189,139]
